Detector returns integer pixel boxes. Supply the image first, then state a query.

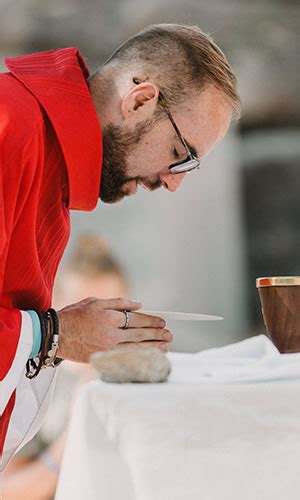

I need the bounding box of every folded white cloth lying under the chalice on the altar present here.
[168,335,300,383]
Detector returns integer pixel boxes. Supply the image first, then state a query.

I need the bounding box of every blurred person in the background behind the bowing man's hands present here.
[0,234,128,500]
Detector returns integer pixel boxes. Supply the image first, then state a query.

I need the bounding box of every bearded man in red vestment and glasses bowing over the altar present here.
[0,24,240,470]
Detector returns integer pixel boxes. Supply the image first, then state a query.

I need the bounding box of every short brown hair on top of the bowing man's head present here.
[104,24,241,117]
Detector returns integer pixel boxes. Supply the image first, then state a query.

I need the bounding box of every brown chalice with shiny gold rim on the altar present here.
[256,276,300,353]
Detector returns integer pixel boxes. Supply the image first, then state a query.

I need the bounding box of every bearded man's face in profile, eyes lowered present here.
[100,85,232,203]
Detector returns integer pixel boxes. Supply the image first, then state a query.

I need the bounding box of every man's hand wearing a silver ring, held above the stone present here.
[57,297,173,363]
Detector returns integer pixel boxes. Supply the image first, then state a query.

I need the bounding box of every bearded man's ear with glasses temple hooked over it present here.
[121,82,159,121]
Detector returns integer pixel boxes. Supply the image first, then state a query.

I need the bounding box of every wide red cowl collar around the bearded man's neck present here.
[5,48,102,210]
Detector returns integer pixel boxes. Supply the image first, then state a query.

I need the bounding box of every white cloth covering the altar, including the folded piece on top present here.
[55,336,300,500]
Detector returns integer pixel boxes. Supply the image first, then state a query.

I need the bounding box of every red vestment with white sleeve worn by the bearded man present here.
[0,48,102,470]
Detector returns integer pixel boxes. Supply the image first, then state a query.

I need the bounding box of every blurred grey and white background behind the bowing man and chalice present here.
[0,0,300,351]
